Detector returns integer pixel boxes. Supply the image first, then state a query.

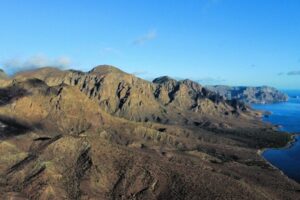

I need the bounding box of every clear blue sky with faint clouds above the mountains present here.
[0,0,300,89]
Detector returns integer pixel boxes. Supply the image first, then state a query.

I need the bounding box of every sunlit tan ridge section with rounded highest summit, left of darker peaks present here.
[16,66,166,121]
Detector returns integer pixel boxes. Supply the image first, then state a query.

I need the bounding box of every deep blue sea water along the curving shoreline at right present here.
[252,91,300,183]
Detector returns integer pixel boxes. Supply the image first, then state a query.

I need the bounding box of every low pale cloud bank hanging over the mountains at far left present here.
[2,54,71,73]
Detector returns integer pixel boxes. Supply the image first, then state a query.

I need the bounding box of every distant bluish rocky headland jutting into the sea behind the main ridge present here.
[206,85,288,104]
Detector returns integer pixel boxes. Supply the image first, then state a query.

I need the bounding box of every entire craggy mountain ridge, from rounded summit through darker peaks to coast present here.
[15,65,250,124]
